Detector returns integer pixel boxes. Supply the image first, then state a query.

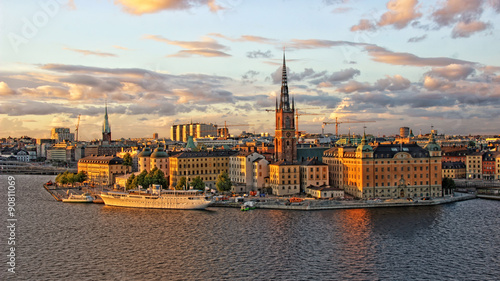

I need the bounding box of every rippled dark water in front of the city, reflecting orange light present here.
[0,176,500,280]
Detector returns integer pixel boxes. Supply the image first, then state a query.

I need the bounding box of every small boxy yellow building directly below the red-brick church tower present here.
[269,160,300,196]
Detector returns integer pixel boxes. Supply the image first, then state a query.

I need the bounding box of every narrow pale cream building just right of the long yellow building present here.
[228,151,264,193]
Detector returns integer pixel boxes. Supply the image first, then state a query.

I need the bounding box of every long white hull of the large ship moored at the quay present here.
[101,191,211,210]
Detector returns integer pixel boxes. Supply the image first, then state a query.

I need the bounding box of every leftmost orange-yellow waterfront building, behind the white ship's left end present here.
[78,156,132,185]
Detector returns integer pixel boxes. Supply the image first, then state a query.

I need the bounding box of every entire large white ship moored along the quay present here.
[101,186,211,210]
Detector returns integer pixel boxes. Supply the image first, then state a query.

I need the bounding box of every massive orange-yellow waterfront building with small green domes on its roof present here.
[323,134,442,199]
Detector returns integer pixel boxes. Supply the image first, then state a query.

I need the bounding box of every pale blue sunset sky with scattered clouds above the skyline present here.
[0,0,500,140]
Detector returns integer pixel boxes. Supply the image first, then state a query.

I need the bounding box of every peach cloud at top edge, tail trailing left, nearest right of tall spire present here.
[351,0,422,31]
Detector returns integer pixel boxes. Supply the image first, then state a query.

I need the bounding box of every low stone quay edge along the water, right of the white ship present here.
[209,194,478,211]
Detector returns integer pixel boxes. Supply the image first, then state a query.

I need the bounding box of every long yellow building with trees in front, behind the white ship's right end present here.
[168,150,238,188]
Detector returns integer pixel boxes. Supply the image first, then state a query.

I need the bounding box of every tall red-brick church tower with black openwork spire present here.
[274,53,297,162]
